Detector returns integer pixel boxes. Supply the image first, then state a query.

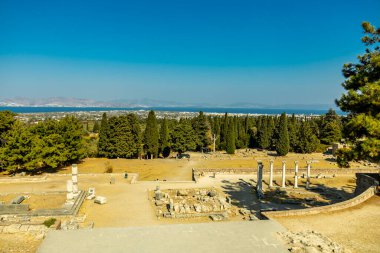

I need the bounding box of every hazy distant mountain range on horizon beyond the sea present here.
[0,97,336,110]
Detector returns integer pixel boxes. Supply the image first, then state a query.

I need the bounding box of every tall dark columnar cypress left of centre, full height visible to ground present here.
[144,111,159,158]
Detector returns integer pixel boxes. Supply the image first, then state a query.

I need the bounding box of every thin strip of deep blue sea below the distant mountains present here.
[0,106,345,115]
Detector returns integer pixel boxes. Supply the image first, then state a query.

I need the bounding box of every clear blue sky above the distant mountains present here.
[0,0,380,105]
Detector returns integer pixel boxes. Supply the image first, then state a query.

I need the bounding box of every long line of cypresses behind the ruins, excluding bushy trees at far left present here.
[98,110,342,158]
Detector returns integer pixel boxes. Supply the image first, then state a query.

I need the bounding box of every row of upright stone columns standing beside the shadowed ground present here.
[256,160,311,189]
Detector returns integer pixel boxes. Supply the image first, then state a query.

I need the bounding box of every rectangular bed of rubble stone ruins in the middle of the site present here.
[152,186,233,220]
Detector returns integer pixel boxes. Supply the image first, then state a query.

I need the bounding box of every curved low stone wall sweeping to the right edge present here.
[261,181,377,218]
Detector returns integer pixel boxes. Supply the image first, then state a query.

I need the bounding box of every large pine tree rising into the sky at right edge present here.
[336,22,380,164]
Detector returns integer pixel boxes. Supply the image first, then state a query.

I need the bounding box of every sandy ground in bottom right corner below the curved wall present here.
[276,196,380,253]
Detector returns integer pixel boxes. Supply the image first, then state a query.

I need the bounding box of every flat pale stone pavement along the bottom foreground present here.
[37,220,288,253]
